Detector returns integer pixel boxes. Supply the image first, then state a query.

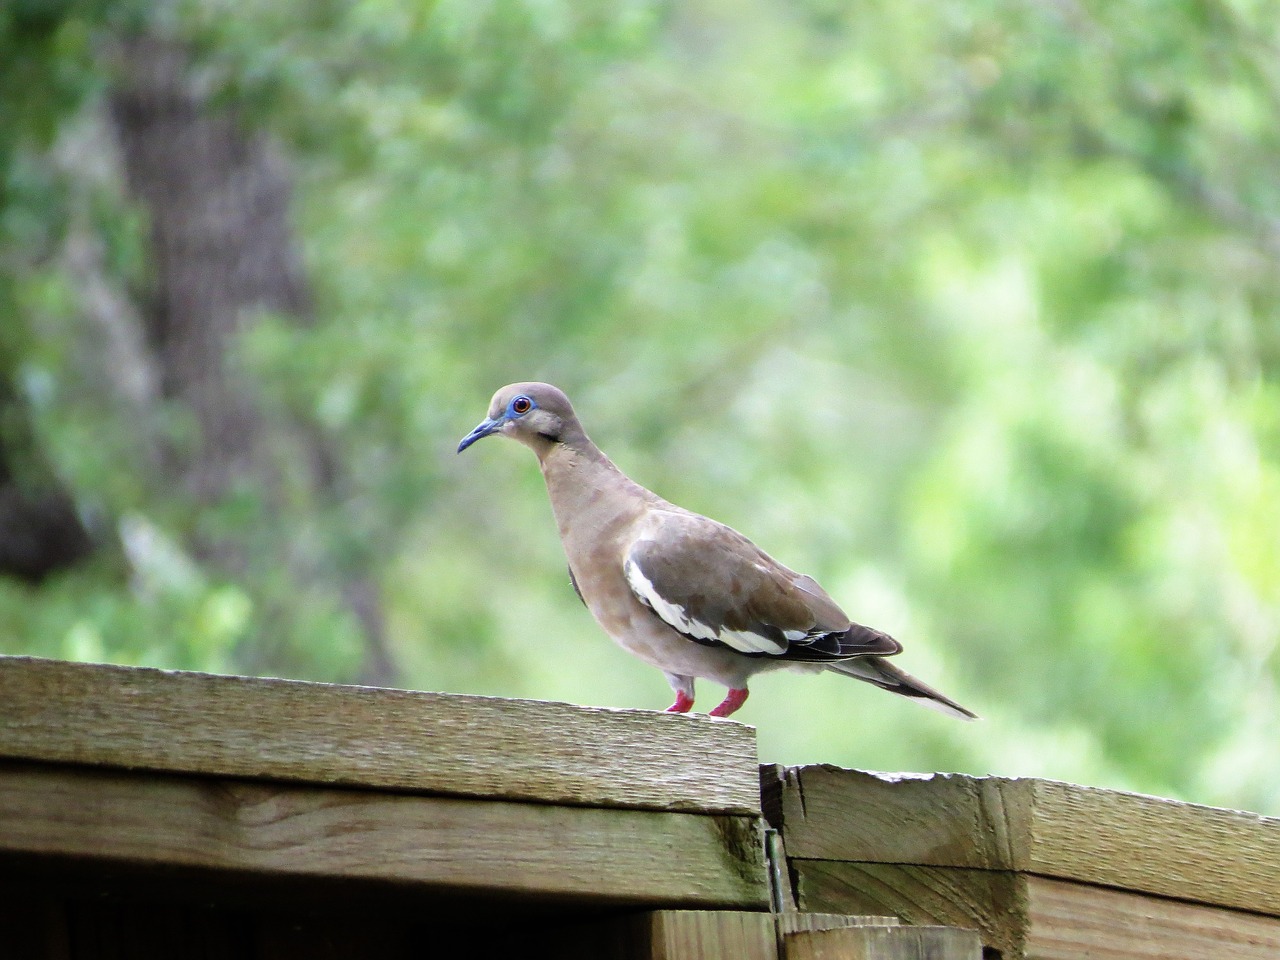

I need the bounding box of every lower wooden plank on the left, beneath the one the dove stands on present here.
[0,762,768,910]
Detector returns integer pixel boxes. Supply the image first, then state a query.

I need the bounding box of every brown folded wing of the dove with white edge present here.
[623,511,902,662]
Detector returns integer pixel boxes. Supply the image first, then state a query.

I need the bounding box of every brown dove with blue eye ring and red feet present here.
[458,381,977,719]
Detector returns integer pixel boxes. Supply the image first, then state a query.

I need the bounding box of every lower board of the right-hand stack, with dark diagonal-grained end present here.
[792,860,1280,960]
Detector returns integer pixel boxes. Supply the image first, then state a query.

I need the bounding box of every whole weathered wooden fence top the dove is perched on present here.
[0,658,1280,960]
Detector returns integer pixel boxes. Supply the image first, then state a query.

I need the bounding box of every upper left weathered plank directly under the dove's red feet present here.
[0,657,759,814]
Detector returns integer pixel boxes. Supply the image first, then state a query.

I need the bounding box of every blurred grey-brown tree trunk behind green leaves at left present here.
[110,35,396,682]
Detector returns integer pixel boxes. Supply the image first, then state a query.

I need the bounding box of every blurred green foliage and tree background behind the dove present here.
[0,0,1280,814]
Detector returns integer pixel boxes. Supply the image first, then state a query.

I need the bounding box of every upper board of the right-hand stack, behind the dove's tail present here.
[767,767,1280,914]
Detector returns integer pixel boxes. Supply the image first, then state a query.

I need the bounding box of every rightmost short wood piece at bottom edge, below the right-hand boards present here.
[782,927,982,960]
